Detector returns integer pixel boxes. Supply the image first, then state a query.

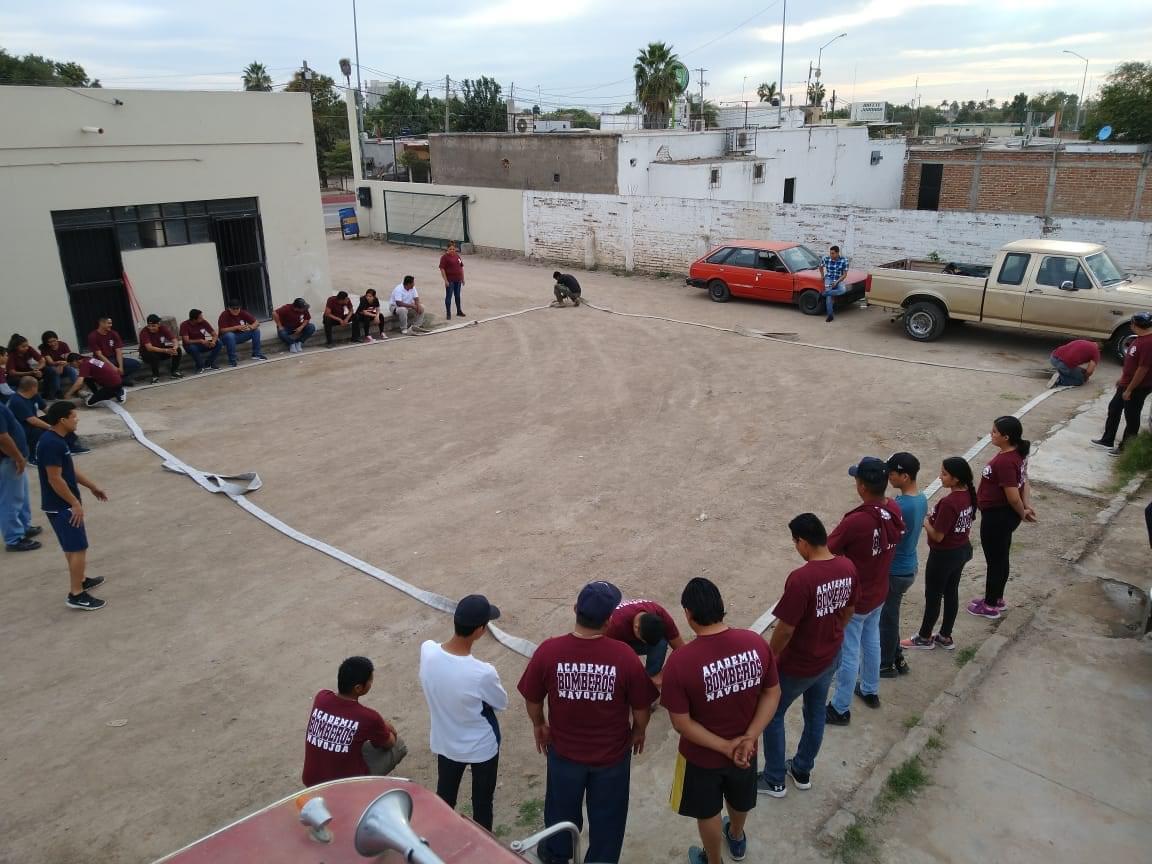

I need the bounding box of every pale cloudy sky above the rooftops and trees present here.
[0,0,1152,113]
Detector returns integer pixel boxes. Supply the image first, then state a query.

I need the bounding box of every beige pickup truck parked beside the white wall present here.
[867,240,1152,358]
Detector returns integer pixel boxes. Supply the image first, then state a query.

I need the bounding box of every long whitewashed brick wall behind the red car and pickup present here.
[524,192,1152,273]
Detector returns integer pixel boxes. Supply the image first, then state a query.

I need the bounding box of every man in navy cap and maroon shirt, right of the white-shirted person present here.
[517,582,660,864]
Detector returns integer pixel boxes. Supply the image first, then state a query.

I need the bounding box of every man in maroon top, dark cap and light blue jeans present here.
[826,456,904,726]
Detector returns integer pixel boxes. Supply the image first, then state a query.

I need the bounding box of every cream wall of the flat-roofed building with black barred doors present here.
[0,86,331,342]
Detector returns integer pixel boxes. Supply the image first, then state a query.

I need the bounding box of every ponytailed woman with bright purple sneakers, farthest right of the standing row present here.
[968,416,1036,620]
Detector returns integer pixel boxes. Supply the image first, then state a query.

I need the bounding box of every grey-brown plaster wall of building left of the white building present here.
[429,132,620,194]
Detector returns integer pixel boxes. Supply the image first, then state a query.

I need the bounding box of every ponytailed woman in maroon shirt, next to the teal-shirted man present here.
[900,456,976,651]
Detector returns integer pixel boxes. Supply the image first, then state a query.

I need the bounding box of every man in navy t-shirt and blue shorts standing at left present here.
[36,402,108,612]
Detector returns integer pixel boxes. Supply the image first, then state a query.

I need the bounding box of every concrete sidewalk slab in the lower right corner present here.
[879,487,1152,864]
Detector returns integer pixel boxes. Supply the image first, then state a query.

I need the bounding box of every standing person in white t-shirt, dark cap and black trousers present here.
[420,594,508,831]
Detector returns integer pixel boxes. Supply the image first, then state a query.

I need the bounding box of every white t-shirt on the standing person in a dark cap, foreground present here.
[420,639,508,764]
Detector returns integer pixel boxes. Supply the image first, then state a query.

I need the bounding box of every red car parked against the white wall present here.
[687,240,870,314]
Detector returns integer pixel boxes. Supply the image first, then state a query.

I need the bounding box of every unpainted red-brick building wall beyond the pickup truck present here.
[901,146,1152,219]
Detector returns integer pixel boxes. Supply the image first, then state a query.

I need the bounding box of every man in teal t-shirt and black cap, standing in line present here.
[880,453,929,679]
